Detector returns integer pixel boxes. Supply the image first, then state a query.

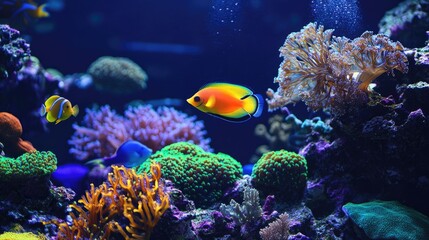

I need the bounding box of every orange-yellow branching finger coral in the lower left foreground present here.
[52,163,170,240]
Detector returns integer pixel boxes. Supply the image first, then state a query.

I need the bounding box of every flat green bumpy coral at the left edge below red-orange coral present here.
[0,151,57,181]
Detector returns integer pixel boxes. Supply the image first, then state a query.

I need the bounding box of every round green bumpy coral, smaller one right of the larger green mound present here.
[252,150,307,200]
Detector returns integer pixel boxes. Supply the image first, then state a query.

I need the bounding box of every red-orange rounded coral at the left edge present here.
[0,112,36,157]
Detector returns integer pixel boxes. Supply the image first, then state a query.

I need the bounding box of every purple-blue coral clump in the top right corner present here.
[378,0,429,47]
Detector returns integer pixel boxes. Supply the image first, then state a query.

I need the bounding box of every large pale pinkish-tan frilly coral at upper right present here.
[267,23,408,115]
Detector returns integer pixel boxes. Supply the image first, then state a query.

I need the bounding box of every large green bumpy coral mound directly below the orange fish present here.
[137,142,242,207]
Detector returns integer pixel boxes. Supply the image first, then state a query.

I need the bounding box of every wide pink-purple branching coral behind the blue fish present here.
[69,105,211,160]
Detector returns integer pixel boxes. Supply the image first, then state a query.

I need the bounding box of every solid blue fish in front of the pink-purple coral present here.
[87,140,152,168]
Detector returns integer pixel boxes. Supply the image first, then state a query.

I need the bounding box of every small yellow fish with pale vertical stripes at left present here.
[40,95,79,124]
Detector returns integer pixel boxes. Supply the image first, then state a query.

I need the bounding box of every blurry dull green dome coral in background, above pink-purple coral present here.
[88,56,148,94]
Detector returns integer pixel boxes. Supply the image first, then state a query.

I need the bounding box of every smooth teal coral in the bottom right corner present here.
[343,201,429,240]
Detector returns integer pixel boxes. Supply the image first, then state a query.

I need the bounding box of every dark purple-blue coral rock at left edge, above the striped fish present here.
[0,25,30,80]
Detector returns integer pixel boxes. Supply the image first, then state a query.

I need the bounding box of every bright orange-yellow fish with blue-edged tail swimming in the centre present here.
[186,83,264,122]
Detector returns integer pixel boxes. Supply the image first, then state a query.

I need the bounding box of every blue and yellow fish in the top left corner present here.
[0,0,49,18]
